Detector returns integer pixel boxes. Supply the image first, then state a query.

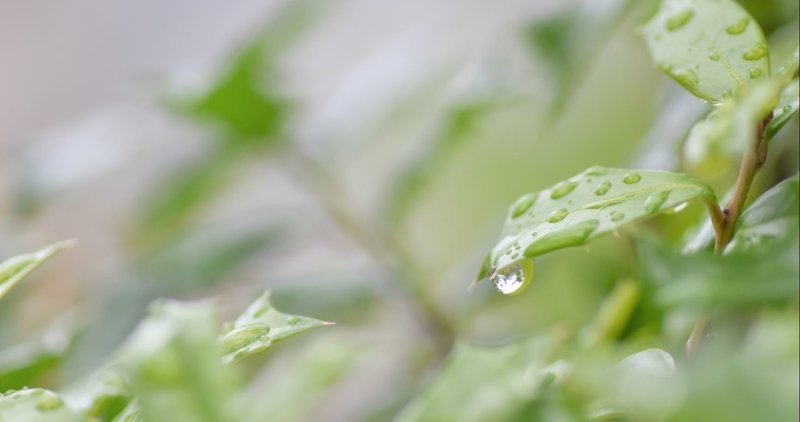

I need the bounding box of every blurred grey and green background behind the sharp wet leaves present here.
[0,0,797,420]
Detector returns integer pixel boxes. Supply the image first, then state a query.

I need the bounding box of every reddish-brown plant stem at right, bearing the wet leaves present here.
[686,112,772,357]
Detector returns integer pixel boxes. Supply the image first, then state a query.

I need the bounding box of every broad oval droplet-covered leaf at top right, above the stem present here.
[642,0,770,104]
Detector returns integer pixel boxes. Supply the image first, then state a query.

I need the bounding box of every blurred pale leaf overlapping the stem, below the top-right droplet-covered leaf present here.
[684,81,780,168]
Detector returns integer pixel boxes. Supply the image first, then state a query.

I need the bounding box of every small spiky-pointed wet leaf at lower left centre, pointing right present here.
[219,292,332,363]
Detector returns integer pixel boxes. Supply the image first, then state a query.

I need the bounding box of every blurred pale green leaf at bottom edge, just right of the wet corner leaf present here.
[64,364,132,421]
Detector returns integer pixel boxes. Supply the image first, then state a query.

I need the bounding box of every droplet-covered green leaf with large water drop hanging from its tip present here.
[484,167,715,274]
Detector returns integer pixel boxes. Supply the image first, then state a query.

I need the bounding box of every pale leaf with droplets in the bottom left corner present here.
[0,388,81,422]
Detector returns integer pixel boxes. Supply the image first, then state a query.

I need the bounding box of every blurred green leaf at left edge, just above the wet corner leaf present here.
[0,314,80,391]
